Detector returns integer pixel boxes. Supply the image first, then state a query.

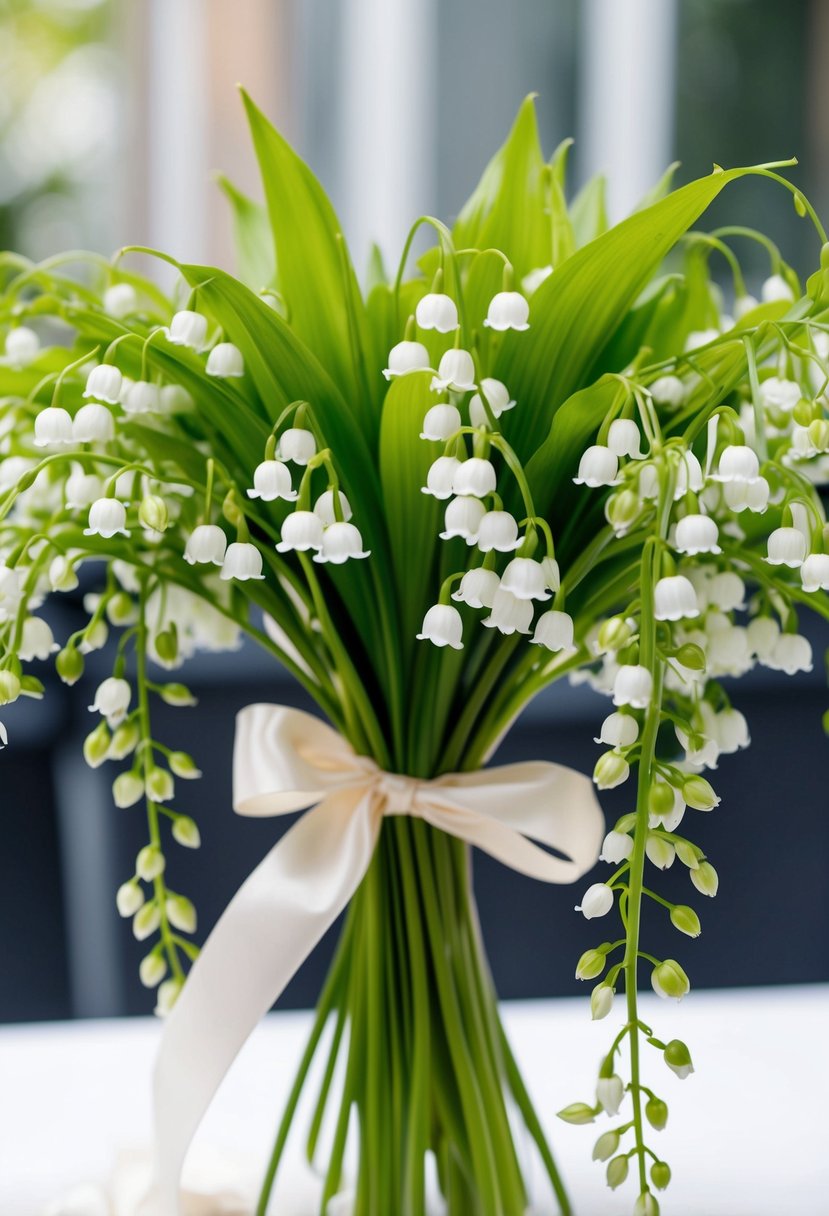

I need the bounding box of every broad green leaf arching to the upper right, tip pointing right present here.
[495,169,782,461]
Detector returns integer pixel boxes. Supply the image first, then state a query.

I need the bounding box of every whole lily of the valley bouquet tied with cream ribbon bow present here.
[0,98,829,1216]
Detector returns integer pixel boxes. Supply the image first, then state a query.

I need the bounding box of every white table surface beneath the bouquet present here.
[0,985,829,1216]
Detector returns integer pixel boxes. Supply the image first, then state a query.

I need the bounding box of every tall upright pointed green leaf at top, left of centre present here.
[242,91,369,427]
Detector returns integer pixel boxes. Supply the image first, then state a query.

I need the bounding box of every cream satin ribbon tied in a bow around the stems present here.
[145,704,604,1216]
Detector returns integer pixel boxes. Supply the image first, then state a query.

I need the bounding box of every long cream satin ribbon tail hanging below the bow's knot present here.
[152,789,379,1216]
